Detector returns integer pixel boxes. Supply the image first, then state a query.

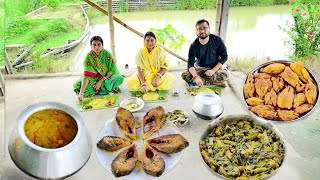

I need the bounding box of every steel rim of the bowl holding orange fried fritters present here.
[242,60,320,122]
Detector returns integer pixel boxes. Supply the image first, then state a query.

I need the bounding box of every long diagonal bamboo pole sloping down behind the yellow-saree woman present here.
[84,0,188,62]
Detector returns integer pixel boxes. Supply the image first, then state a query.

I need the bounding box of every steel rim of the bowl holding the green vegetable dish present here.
[199,114,287,179]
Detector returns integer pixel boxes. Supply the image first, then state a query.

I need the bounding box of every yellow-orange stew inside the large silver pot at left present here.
[24,109,78,149]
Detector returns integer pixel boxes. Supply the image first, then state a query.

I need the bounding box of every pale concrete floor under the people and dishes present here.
[0,71,320,180]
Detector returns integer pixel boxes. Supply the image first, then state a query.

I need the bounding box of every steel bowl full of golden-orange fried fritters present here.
[242,60,319,122]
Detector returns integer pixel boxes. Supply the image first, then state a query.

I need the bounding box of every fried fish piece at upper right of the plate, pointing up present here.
[141,106,165,139]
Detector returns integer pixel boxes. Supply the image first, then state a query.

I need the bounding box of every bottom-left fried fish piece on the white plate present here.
[111,144,138,177]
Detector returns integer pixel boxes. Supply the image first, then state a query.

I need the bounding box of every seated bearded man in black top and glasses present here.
[181,19,228,87]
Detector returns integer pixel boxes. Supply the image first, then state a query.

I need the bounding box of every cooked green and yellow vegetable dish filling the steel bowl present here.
[200,120,285,180]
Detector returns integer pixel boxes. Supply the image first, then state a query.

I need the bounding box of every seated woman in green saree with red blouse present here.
[73,36,124,102]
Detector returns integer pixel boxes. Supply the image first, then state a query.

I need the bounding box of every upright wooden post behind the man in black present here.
[215,0,230,42]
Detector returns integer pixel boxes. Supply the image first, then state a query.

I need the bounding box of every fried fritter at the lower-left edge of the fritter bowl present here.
[249,105,278,120]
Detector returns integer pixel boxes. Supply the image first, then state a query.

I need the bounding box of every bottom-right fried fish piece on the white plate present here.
[141,143,166,177]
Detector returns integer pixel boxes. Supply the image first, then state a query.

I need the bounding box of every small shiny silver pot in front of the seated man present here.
[192,92,224,120]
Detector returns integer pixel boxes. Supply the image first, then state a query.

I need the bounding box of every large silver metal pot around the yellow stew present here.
[8,102,92,179]
